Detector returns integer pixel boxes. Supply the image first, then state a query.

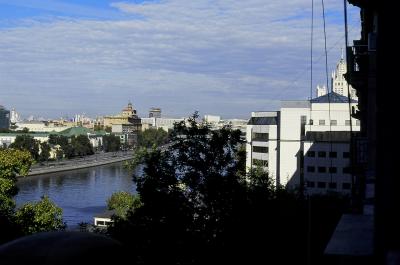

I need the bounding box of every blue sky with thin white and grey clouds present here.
[0,0,360,118]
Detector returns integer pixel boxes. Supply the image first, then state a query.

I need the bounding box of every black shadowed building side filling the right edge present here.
[328,0,400,264]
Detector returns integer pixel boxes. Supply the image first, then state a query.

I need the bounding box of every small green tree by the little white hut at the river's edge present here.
[107,191,142,218]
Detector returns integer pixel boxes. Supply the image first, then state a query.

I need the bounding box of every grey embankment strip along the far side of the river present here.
[24,151,133,176]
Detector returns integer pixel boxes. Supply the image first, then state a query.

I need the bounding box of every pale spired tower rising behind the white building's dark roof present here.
[332,49,357,100]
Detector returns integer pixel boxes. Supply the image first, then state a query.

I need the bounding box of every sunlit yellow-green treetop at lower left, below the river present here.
[15,196,66,235]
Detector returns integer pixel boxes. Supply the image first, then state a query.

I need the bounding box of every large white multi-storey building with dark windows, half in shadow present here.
[246,93,360,193]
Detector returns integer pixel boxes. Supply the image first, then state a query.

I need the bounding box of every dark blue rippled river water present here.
[15,162,136,229]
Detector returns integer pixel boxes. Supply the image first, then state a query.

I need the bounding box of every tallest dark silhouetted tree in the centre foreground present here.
[110,114,246,263]
